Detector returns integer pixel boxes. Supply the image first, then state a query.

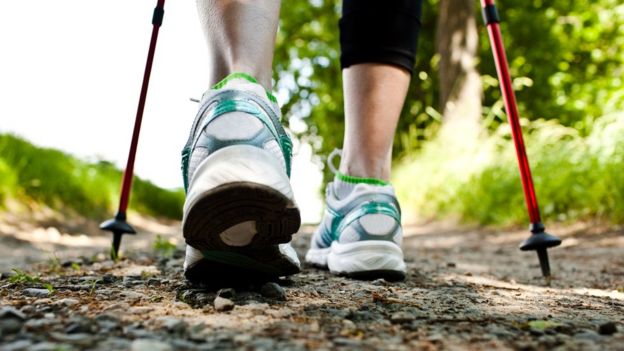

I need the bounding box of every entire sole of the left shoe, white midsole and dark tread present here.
[182,145,301,284]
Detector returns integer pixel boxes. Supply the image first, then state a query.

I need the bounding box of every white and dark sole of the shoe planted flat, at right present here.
[306,240,406,281]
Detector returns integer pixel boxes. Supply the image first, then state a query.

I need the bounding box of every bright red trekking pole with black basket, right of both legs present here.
[481,0,561,278]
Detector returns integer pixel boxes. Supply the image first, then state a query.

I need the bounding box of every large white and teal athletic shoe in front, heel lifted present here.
[182,73,301,283]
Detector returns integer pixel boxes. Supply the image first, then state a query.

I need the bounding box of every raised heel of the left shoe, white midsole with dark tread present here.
[182,145,301,254]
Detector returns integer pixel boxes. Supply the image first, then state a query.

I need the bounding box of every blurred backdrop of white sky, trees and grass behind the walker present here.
[0,0,624,264]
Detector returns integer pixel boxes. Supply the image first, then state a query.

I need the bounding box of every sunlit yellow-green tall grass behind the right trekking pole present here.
[393,113,624,225]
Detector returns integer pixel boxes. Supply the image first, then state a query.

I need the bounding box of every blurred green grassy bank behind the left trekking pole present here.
[0,134,184,219]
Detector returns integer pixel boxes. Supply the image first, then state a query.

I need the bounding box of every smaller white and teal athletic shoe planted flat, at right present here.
[305,151,405,281]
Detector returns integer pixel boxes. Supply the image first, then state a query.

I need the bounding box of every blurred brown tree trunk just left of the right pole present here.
[436,0,482,139]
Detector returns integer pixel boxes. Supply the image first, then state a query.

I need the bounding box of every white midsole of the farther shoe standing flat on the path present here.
[324,240,406,273]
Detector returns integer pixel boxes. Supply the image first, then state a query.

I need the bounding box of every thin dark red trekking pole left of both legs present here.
[100,0,165,260]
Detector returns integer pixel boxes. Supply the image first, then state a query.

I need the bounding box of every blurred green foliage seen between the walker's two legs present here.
[274,0,344,164]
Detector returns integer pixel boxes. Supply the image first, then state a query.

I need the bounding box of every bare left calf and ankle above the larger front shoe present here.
[197,0,280,90]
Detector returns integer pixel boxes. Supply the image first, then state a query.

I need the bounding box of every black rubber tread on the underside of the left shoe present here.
[182,182,301,282]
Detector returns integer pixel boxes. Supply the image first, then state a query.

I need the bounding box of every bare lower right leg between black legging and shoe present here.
[340,63,410,180]
